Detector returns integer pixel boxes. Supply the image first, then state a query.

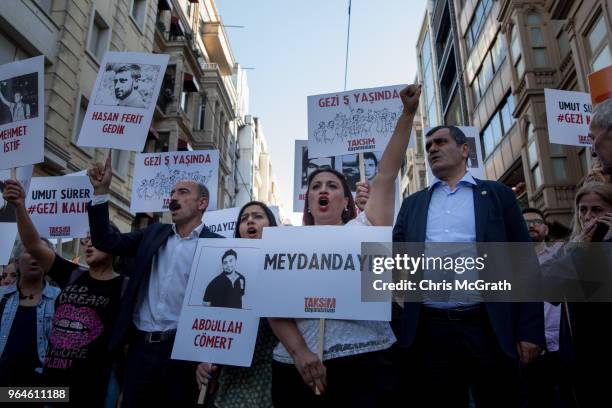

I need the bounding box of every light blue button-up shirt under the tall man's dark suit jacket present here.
[423,172,477,309]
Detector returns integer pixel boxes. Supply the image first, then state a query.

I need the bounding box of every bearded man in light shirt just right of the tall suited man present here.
[523,208,563,407]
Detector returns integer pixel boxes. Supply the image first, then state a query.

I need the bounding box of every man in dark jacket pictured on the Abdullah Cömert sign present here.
[204,249,245,309]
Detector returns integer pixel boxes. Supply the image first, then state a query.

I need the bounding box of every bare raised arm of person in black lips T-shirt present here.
[3,180,55,273]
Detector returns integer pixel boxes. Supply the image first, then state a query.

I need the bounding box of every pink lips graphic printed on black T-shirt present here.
[50,305,104,349]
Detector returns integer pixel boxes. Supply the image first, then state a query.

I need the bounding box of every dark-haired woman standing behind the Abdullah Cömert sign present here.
[196,201,278,408]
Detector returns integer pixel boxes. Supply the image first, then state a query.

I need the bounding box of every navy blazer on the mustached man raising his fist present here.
[88,202,223,350]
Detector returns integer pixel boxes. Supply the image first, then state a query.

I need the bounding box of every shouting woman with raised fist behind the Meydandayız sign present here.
[268,85,420,407]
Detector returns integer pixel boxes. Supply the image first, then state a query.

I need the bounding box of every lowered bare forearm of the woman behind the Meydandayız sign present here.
[268,317,327,393]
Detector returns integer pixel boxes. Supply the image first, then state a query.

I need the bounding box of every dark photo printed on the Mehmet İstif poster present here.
[0,72,38,125]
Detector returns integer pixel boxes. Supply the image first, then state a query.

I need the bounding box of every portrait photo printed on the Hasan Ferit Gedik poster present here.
[94,62,160,109]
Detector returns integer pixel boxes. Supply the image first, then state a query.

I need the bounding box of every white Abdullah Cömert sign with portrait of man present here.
[172,238,261,367]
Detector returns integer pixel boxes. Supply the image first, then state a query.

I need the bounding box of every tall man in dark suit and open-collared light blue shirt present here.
[393,126,544,408]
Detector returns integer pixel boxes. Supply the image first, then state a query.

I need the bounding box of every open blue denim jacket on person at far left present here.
[0,281,60,373]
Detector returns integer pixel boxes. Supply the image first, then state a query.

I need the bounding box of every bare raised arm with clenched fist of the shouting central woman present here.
[365,85,421,226]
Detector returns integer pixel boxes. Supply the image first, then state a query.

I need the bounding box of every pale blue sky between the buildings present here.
[215,0,427,223]
